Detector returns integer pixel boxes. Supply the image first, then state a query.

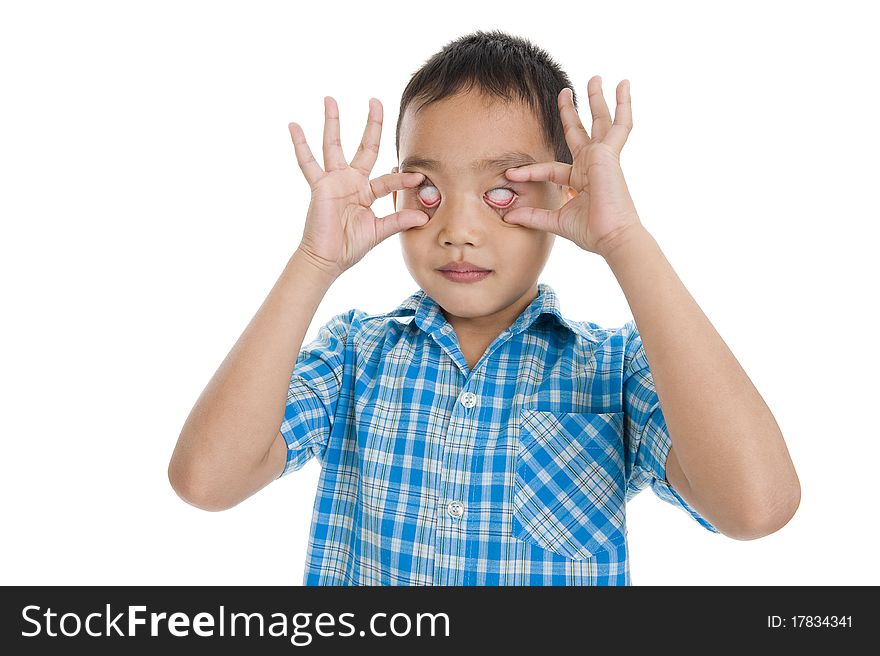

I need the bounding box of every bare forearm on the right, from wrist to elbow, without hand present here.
[606,227,800,533]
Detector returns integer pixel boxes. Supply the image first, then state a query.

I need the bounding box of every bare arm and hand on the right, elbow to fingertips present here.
[503,75,800,540]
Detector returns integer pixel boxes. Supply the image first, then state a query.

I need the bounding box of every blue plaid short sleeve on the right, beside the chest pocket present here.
[623,321,720,533]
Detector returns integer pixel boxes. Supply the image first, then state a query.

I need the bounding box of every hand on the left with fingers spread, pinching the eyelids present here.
[287,96,428,277]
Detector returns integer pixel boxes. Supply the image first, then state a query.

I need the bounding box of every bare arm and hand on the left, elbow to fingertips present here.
[168,96,428,510]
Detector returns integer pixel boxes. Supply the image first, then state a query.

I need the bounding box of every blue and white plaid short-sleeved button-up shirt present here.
[279,283,718,585]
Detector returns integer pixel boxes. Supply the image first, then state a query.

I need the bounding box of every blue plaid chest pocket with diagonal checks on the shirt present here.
[511,409,626,560]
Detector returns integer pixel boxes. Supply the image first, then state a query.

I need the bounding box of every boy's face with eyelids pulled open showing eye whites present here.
[393,91,573,336]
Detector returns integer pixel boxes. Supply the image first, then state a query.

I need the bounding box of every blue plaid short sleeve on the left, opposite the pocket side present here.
[278,310,357,478]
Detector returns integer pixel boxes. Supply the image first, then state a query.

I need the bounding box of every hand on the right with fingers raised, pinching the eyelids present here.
[504,75,642,257]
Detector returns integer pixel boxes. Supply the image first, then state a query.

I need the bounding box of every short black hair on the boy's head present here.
[394,30,577,164]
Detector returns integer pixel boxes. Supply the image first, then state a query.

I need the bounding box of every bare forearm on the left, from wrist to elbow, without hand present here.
[169,250,334,498]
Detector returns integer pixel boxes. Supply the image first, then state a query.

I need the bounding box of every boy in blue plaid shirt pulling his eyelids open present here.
[169,31,800,585]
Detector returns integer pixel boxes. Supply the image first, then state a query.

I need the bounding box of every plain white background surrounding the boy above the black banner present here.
[0,0,880,585]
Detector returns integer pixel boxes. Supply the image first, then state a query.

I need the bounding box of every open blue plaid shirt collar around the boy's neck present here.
[365,283,593,339]
